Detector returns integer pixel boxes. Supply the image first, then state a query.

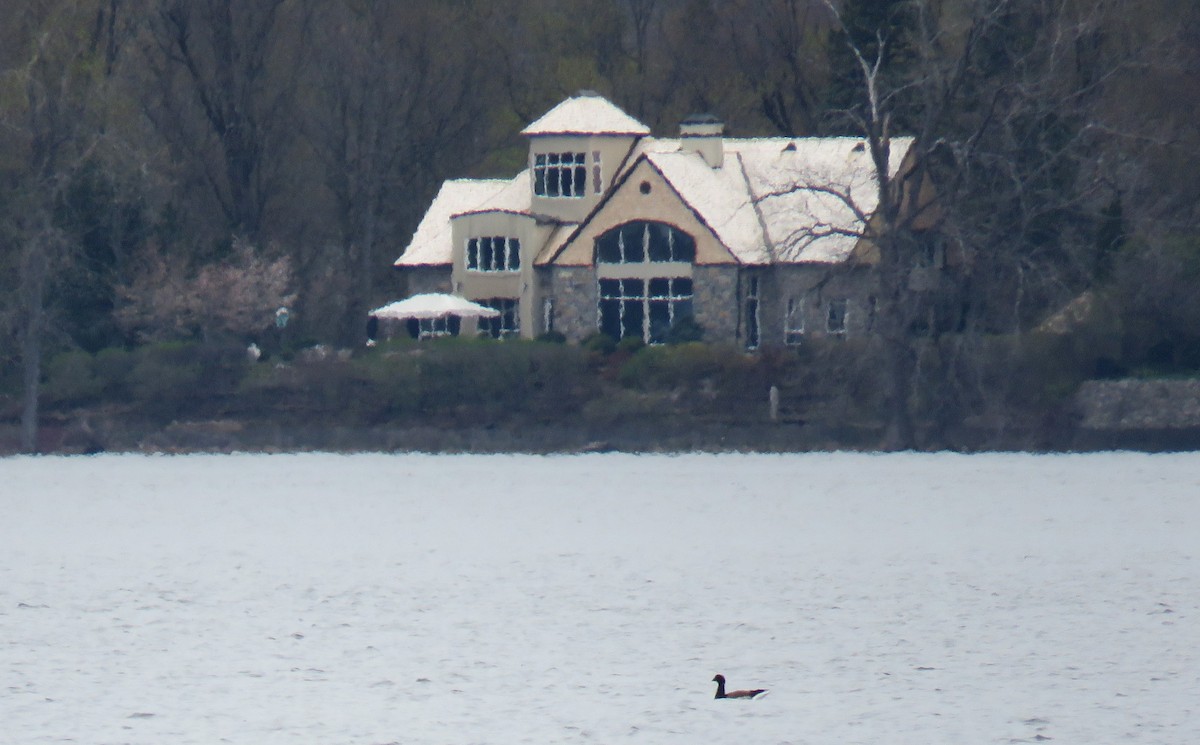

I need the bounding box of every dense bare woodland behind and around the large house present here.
[0,0,1200,446]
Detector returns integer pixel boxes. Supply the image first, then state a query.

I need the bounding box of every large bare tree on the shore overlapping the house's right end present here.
[799,0,1132,449]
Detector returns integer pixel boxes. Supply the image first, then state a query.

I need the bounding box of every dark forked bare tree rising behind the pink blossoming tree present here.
[142,0,301,240]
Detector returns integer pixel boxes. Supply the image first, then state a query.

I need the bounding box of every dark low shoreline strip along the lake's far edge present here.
[0,419,1200,456]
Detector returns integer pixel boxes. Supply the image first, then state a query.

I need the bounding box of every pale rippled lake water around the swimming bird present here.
[0,453,1200,745]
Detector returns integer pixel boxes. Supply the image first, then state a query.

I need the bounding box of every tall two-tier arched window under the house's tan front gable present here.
[595,222,696,344]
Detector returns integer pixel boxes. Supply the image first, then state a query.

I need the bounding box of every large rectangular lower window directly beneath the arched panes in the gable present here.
[600,277,692,344]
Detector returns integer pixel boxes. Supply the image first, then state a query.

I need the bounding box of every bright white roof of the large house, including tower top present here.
[396,95,913,266]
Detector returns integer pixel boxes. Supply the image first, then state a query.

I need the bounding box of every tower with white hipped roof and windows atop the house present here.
[521,91,650,222]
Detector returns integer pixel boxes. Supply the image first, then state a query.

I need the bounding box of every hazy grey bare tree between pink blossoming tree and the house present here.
[298,0,488,342]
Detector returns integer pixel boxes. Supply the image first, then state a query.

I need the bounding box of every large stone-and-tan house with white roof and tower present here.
[396,92,912,348]
